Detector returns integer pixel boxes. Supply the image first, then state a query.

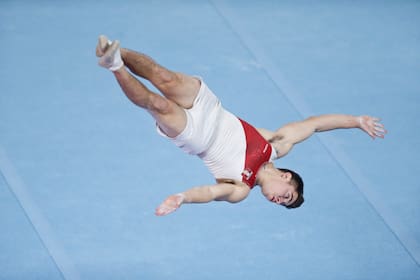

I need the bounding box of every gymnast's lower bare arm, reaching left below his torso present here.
[155,183,250,216]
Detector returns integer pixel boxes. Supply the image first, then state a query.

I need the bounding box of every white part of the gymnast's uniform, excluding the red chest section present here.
[157,78,276,181]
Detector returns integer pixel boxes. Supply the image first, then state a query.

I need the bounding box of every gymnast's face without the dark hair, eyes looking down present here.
[261,171,299,206]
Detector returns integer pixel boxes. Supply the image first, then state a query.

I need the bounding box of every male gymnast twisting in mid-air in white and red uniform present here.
[96,35,386,216]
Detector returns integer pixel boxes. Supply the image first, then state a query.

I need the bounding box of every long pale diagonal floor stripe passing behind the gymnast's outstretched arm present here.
[209,0,420,267]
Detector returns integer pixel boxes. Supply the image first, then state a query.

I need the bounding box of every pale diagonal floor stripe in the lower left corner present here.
[0,146,80,280]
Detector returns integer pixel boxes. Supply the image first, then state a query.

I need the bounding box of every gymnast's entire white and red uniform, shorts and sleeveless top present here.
[157,77,276,188]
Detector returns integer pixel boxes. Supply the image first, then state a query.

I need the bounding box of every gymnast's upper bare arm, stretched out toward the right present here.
[259,114,386,157]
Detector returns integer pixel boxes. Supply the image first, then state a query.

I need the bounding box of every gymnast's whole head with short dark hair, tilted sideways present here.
[260,168,304,209]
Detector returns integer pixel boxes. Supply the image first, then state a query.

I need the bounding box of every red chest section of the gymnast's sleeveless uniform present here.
[239,119,272,189]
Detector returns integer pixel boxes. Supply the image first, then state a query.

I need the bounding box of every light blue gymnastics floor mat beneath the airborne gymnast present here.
[0,0,420,280]
